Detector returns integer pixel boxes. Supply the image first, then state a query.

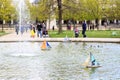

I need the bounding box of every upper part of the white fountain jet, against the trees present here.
[13,0,30,31]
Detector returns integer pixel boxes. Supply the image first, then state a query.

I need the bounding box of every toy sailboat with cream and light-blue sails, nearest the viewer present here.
[83,53,101,68]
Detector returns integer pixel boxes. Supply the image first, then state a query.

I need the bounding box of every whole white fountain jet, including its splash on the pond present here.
[11,0,36,57]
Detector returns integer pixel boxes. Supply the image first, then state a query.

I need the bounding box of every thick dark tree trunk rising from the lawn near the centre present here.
[57,0,62,34]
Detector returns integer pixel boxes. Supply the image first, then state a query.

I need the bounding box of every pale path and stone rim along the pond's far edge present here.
[0,31,120,43]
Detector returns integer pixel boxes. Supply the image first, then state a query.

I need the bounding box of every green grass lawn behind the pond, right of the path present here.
[49,30,120,38]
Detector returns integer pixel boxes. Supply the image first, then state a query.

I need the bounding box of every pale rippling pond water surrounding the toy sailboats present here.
[0,42,120,80]
